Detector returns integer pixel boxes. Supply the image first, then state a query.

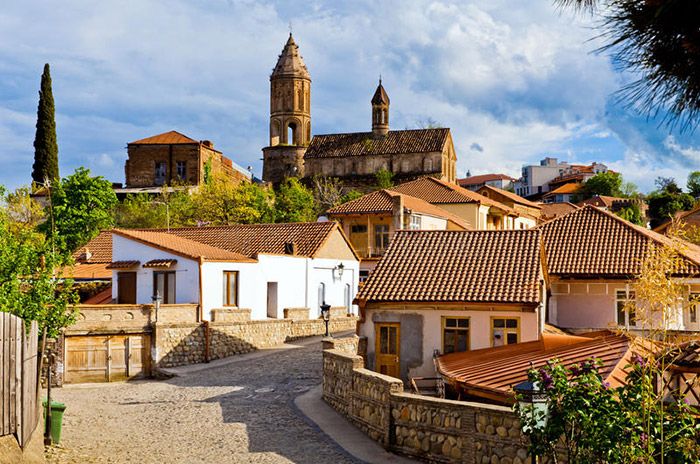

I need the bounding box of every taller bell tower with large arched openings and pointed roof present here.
[263,33,311,184]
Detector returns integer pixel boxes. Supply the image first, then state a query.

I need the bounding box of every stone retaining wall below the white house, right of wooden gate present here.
[153,316,357,367]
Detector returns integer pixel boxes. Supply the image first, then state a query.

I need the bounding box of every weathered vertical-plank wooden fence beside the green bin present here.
[0,312,40,447]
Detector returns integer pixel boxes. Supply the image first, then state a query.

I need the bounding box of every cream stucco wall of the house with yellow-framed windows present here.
[359,307,540,377]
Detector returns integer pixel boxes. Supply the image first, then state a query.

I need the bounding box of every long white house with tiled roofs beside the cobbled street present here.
[109,222,359,320]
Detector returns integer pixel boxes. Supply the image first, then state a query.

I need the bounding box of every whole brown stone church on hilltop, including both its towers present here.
[263,33,457,191]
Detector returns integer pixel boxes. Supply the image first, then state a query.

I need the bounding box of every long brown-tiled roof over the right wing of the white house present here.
[162,221,342,257]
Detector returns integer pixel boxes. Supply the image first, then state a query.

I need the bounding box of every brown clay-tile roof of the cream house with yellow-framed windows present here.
[356,229,542,305]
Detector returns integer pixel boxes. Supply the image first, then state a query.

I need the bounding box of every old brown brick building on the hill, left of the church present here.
[124,131,250,188]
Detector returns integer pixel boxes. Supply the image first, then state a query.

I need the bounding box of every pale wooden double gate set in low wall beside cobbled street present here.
[65,334,151,383]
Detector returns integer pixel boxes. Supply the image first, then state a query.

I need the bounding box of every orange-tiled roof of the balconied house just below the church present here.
[327,189,471,229]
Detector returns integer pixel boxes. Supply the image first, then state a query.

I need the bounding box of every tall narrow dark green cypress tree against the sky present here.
[32,63,59,184]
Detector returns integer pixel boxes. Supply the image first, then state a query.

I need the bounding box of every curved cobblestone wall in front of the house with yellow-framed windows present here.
[323,340,532,464]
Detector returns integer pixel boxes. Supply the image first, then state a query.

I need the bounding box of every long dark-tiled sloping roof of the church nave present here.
[304,128,450,159]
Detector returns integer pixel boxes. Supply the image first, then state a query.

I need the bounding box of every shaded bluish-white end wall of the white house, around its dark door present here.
[112,234,199,304]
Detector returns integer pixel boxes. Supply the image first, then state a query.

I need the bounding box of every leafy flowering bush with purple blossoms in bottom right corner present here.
[514,356,700,464]
